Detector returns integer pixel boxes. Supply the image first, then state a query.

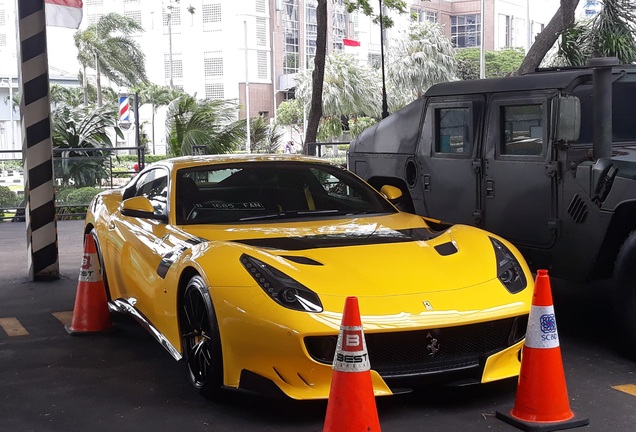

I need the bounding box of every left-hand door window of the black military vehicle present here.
[435,108,472,154]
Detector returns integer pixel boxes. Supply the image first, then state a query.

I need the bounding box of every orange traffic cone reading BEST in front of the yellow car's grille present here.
[323,297,380,432]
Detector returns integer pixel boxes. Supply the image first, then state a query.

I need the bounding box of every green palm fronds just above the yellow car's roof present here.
[166,94,246,156]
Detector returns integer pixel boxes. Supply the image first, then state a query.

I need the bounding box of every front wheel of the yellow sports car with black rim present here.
[179,275,223,398]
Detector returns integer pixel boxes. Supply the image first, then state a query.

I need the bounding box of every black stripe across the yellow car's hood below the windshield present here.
[231,228,442,251]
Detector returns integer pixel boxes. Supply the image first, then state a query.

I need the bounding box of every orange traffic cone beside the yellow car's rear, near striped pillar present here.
[66,235,113,335]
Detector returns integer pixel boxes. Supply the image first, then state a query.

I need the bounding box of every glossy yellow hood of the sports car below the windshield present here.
[181,213,505,296]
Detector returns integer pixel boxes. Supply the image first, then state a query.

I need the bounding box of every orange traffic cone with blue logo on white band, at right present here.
[496,270,589,431]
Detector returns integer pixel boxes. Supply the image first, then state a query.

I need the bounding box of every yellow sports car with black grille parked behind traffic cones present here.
[85,155,533,399]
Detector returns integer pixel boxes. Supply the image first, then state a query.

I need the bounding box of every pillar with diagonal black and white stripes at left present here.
[16,0,60,280]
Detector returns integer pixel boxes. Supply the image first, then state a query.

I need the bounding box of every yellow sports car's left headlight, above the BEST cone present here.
[240,254,323,312]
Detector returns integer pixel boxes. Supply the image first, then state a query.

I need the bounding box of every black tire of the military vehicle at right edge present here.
[613,231,636,360]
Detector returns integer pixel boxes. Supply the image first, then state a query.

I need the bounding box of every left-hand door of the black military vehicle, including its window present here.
[416,95,484,225]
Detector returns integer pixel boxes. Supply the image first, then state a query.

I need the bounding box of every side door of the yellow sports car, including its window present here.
[109,168,171,318]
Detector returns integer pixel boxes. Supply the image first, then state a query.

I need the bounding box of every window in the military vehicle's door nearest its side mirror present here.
[501,104,543,156]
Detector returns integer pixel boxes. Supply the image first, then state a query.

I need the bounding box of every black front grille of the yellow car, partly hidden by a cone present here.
[305,315,528,378]
